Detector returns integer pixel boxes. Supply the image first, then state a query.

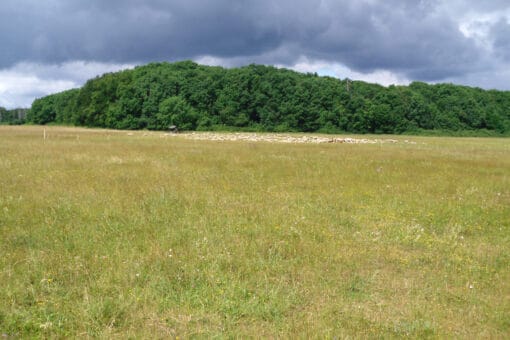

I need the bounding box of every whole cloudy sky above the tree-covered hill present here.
[0,0,510,108]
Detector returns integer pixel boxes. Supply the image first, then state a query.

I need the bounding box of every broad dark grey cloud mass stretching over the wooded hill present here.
[0,0,497,79]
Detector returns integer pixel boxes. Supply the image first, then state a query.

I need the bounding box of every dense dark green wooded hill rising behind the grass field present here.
[26,61,510,135]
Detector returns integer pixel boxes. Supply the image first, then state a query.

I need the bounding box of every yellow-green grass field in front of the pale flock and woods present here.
[0,126,510,338]
